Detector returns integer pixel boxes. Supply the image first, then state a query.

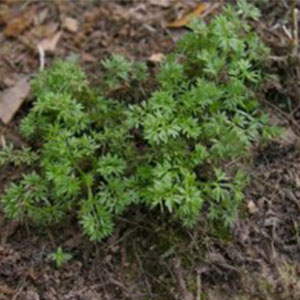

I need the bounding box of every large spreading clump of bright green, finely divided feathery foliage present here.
[0,1,277,241]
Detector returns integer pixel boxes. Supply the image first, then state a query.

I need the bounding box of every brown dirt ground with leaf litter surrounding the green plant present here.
[0,0,300,300]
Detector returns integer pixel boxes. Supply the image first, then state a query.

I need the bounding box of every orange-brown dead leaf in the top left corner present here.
[4,8,35,37]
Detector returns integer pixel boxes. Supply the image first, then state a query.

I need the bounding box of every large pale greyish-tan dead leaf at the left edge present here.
[0,77,30,124]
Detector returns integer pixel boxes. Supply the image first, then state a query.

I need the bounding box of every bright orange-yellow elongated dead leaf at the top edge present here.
[168,2,219,28]
